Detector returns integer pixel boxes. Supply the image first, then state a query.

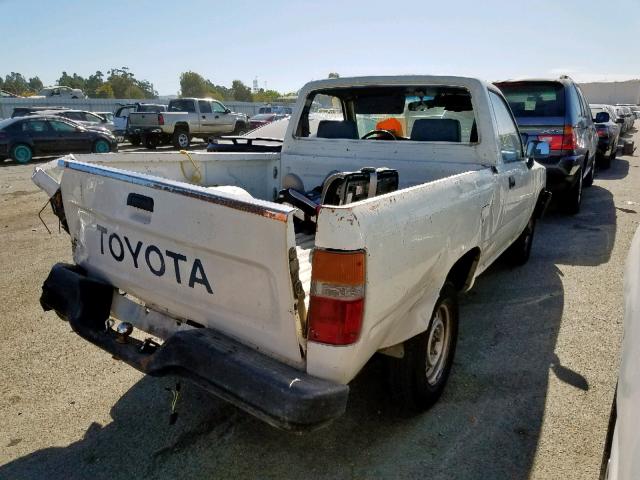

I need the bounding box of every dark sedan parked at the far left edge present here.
[0,116,118,163]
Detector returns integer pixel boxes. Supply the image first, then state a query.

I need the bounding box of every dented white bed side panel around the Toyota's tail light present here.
[307,169,500,383]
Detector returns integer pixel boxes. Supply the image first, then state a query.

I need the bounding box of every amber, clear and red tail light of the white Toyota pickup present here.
[308,248,365,345]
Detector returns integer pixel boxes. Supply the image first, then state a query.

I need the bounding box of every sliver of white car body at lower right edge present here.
[600,229,640,480]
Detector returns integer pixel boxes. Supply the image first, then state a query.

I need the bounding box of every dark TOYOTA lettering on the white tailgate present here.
[96,224,213,294]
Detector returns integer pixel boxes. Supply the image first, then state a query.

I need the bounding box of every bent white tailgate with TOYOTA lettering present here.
[60,160,304,367]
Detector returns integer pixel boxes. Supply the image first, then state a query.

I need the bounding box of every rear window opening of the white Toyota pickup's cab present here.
[296,86,477,143]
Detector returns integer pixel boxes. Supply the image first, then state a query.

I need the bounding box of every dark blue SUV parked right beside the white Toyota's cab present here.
[496,76,598,214]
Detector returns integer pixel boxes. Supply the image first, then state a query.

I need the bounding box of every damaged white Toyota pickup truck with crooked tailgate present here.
[33,76,550,430]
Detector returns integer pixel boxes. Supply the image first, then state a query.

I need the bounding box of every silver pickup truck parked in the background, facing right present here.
[128,98,249,149]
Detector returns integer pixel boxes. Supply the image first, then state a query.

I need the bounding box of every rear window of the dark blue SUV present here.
[497,82,565,117]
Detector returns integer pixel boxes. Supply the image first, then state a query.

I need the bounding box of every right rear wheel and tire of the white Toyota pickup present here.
[387,282,458,412]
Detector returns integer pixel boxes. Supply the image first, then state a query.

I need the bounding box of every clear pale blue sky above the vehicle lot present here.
[0,0,640,94]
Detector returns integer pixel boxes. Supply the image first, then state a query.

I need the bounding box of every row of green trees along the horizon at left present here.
[0,67,296,102]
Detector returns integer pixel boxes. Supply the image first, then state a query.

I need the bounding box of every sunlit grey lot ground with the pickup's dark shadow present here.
[0,129,640,479]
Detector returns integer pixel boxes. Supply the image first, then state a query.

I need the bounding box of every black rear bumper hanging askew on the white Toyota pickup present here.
[40,264,349,431]
